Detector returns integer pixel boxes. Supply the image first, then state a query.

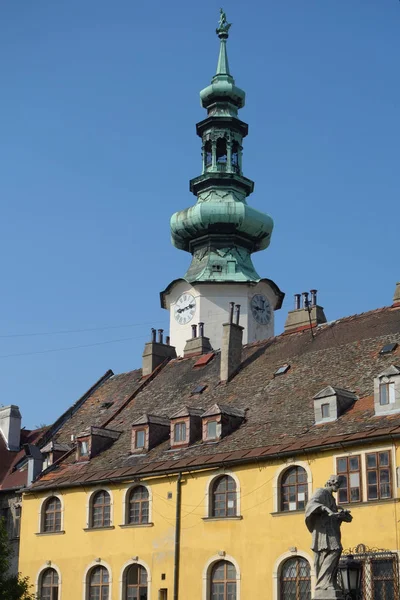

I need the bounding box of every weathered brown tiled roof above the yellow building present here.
[29,307,400,488]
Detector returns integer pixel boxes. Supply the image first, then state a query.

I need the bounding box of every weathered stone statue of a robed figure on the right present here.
[306,475,353,600]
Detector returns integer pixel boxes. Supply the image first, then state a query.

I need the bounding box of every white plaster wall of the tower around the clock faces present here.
[166,281,276,356]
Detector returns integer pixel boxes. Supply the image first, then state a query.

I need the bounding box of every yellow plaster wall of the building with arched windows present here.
[20,444,400,600]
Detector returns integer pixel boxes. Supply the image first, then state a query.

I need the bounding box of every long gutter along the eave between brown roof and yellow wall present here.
[24,433,400,494]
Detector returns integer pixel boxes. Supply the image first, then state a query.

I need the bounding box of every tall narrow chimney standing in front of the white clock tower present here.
[220,302,244,381]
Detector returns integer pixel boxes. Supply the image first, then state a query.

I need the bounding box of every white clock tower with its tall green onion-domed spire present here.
[161,9,284,356]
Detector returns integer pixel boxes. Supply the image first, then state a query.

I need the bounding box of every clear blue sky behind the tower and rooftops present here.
[0,0,400,427]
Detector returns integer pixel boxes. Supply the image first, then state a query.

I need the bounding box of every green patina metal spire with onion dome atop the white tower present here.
[171,9,273,283]
